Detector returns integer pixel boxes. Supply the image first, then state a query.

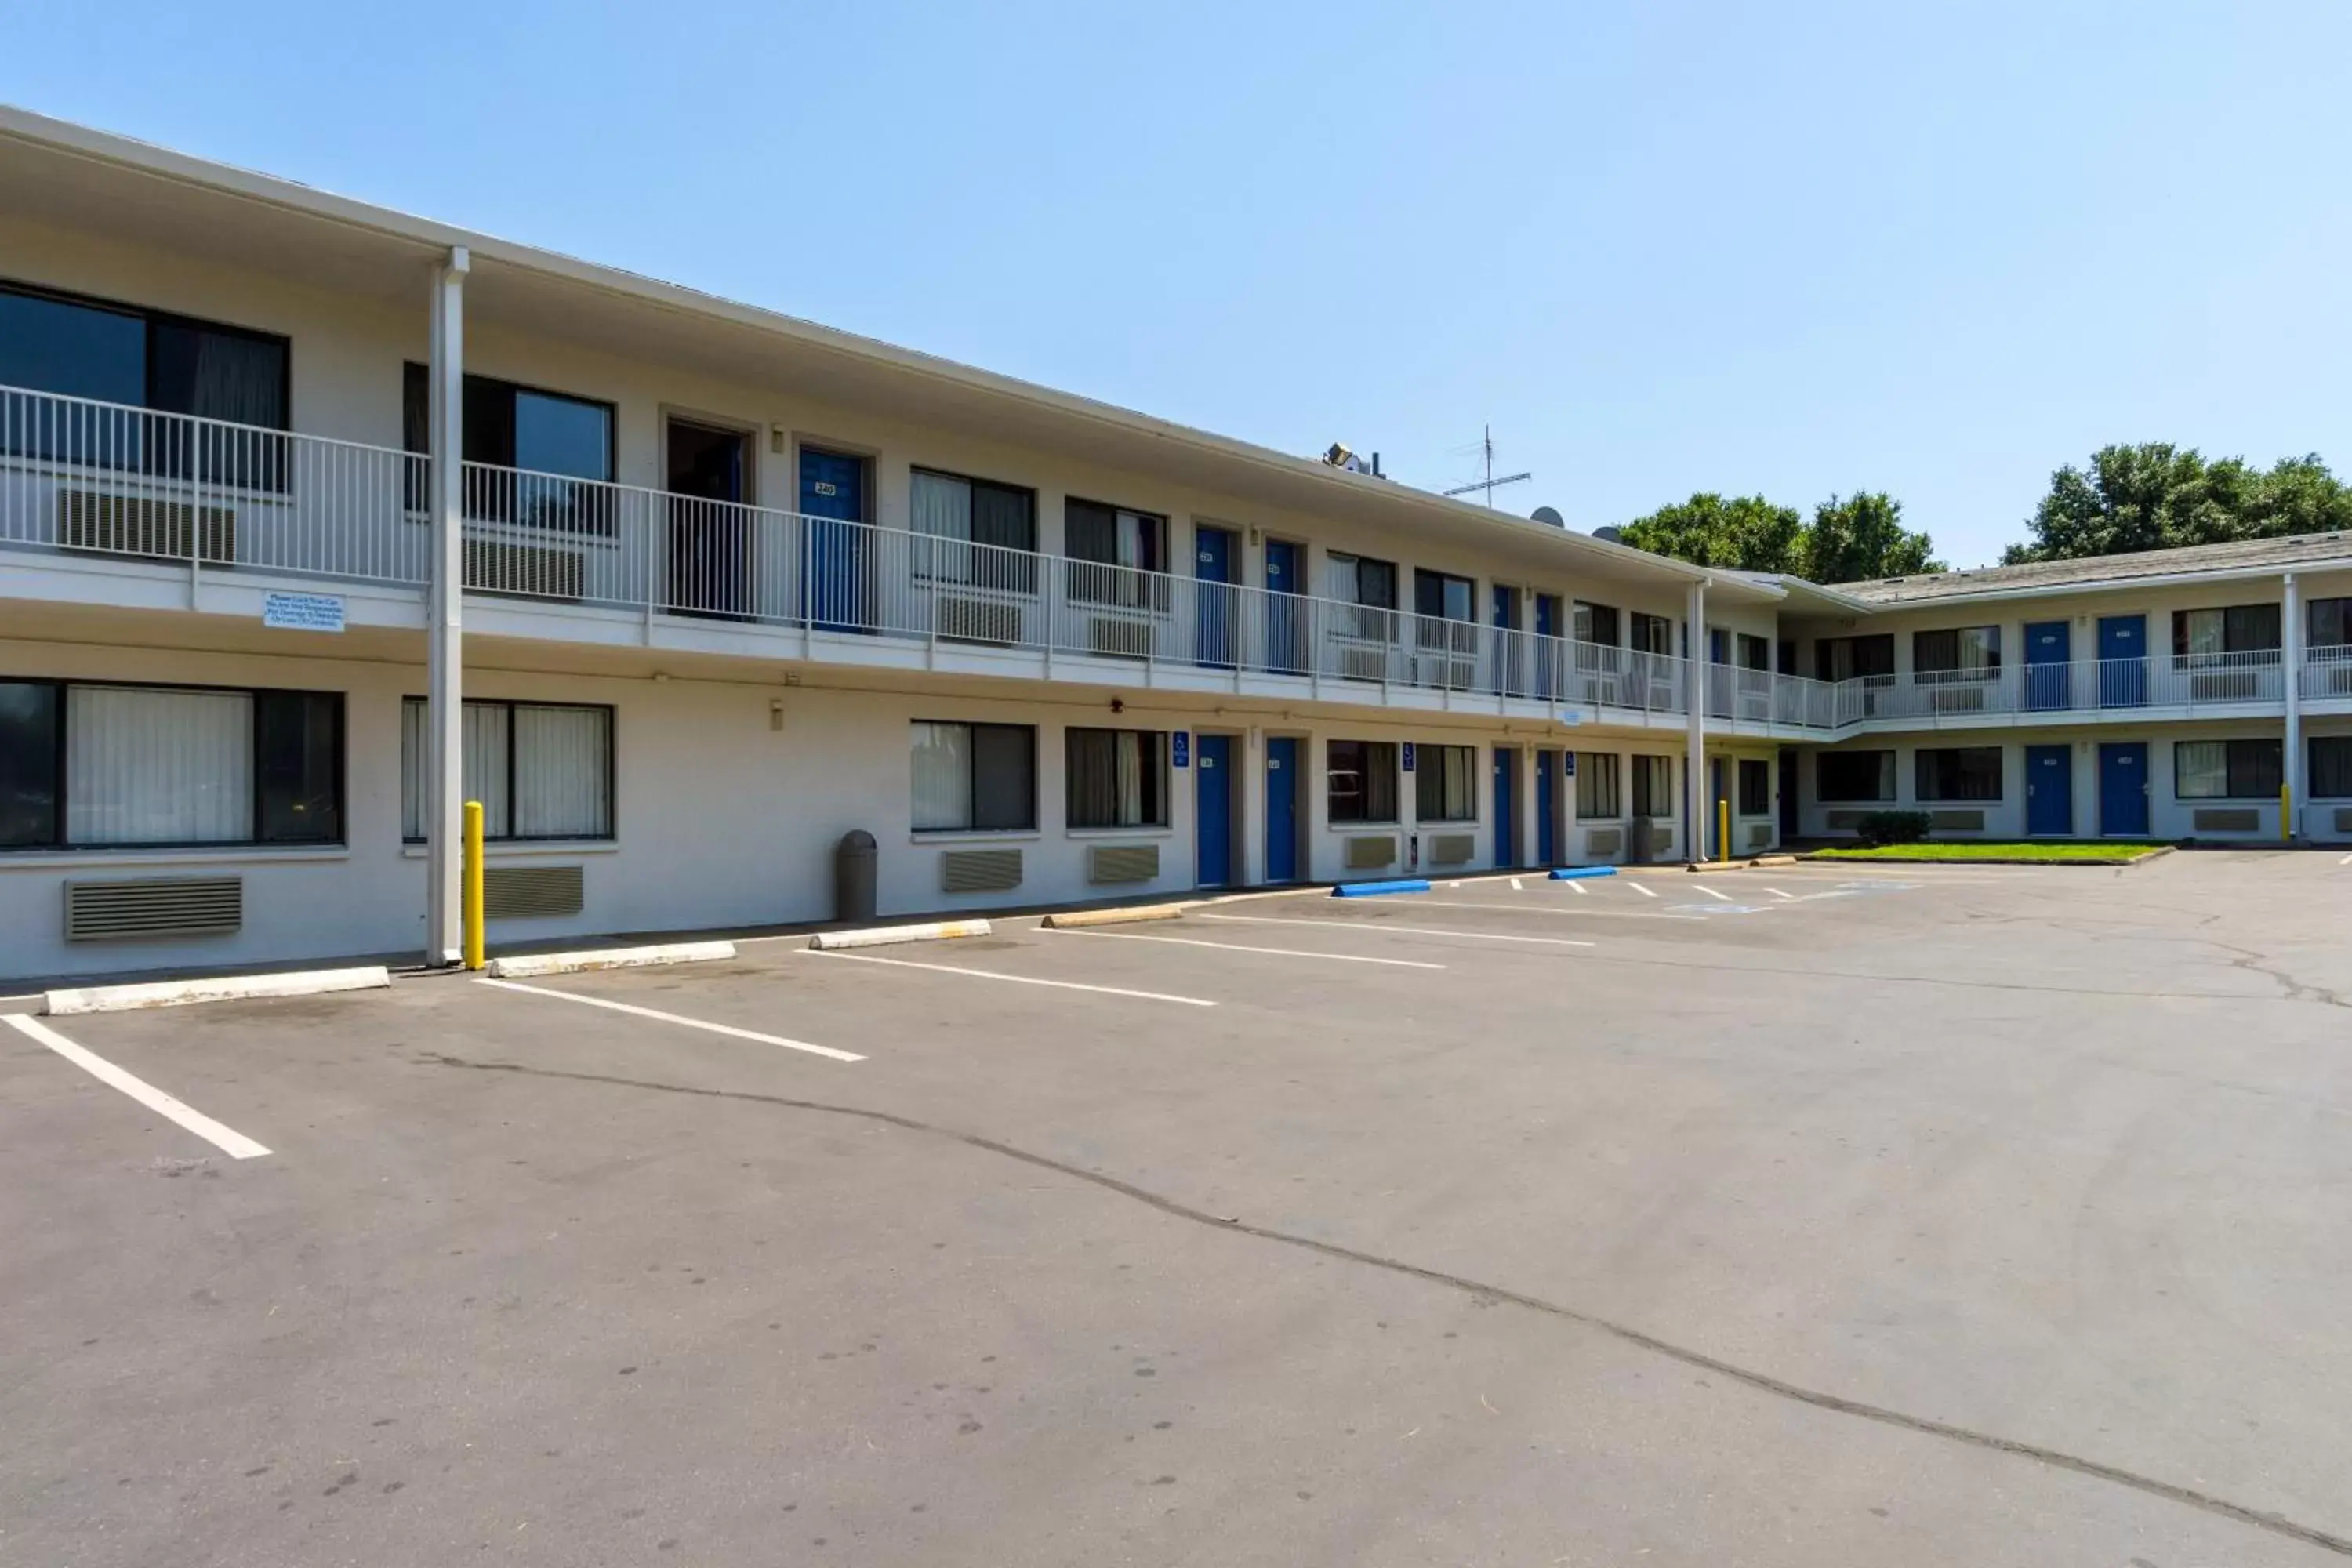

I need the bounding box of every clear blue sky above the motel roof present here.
[0,0,2352,564]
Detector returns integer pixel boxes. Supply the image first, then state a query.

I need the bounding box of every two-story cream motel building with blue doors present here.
[0,111,2352,975]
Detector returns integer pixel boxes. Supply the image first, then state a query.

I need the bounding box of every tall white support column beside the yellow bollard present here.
[426,247,470,964]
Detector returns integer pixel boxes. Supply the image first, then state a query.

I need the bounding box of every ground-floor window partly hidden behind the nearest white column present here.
[400,696,612,844]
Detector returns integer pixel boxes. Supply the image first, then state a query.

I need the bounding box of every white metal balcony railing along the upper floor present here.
[0,388,2314,731]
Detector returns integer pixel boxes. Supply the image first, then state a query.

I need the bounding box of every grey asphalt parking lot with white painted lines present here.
[0,853,2352,1568]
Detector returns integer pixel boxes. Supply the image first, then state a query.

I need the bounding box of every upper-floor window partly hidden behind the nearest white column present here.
[400,362,619,534]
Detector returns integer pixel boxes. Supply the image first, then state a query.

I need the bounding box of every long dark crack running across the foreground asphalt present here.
[421,1053,2352,1556]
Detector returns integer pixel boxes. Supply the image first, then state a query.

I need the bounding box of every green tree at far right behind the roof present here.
[2002,442,2352,564]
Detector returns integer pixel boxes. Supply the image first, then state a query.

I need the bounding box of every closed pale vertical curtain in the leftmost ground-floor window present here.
[66,687,254,844]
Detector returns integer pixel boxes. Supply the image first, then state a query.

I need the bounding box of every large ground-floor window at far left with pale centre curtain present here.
[0,682,343,848]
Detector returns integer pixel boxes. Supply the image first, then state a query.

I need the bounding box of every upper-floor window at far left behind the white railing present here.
[0,285,289,489]
